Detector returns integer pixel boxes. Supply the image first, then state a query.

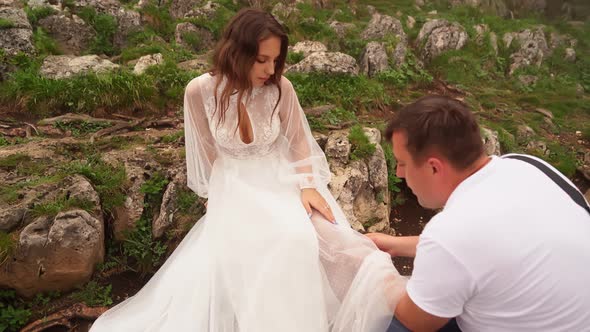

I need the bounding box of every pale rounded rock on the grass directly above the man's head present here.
[417,19,469,61]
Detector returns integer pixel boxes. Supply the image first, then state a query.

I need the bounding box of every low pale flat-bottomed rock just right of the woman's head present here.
[287,52,359,75]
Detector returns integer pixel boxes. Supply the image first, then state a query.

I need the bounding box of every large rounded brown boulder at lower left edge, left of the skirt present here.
[0,175,105,297]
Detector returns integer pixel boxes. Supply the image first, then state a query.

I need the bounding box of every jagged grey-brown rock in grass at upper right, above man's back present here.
[503,27,550,75]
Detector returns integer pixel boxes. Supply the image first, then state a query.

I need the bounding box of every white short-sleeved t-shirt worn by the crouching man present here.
[407,157,590,332]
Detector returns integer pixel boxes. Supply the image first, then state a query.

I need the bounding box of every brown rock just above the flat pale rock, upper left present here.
[39,14,95,55]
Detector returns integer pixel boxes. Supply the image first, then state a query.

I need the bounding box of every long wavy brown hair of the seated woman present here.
[210,8,289,129]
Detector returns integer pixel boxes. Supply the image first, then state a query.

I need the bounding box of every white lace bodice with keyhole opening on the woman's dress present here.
[203,77,280,159]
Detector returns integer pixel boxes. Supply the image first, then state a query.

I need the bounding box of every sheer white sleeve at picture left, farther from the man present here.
[184,76,217,198]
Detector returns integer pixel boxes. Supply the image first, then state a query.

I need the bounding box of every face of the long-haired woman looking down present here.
[250,36,281,87]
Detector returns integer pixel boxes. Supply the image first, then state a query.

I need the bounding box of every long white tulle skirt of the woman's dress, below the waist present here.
[91,155,405,332]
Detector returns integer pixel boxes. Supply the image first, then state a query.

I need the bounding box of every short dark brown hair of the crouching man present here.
[385,95,484,170]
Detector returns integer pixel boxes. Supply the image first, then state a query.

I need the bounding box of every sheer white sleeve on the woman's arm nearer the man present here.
[278,77,330,189]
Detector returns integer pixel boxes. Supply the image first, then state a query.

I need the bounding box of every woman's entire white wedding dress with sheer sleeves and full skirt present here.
[91,74,405,332]
